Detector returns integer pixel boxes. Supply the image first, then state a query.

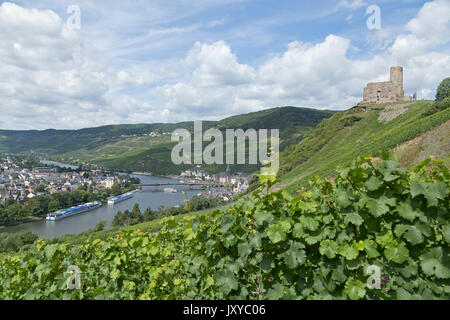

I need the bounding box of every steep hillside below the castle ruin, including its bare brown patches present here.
[278,101,450,192]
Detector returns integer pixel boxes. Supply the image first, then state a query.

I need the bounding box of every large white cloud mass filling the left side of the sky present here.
[0,2,164,129]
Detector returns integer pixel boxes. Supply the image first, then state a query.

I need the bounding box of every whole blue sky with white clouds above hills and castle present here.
[0,0,450,129]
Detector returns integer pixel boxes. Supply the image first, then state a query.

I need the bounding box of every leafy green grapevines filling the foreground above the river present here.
[0,154,450,300]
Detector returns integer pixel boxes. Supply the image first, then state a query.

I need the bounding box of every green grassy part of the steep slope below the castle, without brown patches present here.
[281,101,450,193]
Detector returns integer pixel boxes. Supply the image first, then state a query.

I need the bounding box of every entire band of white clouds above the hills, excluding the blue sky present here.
[0,0,450,129]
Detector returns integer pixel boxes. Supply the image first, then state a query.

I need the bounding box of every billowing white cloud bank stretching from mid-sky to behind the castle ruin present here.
[157,0,450,119]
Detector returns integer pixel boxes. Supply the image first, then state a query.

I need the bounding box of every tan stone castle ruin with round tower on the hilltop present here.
[359,67,411,105]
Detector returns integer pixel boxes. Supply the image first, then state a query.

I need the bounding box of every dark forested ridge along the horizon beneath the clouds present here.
[0,107,334,154]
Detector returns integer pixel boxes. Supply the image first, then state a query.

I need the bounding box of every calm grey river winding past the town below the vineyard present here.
[2,175,202,239]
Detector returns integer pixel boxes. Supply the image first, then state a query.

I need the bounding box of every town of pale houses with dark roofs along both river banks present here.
[0,154,252,204]
